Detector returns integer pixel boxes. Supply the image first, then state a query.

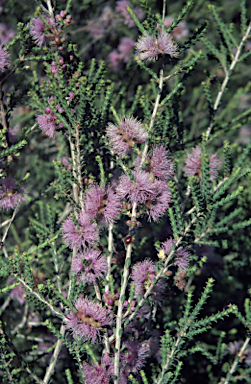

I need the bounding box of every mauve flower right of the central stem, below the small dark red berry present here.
[131,259,156,296]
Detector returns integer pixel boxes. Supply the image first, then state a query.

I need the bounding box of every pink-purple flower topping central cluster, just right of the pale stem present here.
[149,144,174,181]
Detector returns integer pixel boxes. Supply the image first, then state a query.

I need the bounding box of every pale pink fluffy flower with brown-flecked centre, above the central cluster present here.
[106,117,148,158]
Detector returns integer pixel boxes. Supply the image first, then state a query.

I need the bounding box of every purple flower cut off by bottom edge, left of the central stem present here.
[83,353,114,384]
